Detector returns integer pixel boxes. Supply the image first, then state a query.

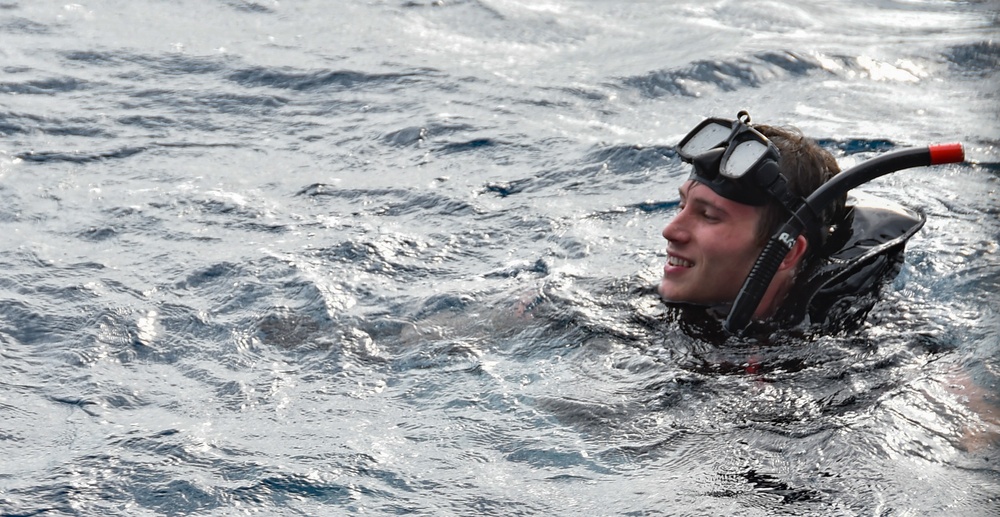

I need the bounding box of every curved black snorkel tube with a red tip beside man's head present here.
[725,144,965,333]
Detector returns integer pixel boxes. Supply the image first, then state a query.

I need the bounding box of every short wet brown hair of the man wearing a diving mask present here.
[753,121,847,262]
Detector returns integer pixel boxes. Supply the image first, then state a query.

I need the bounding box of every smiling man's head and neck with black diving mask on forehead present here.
[659,112,846,319]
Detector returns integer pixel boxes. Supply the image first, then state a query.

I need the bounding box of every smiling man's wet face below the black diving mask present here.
[659,180,763,305]
